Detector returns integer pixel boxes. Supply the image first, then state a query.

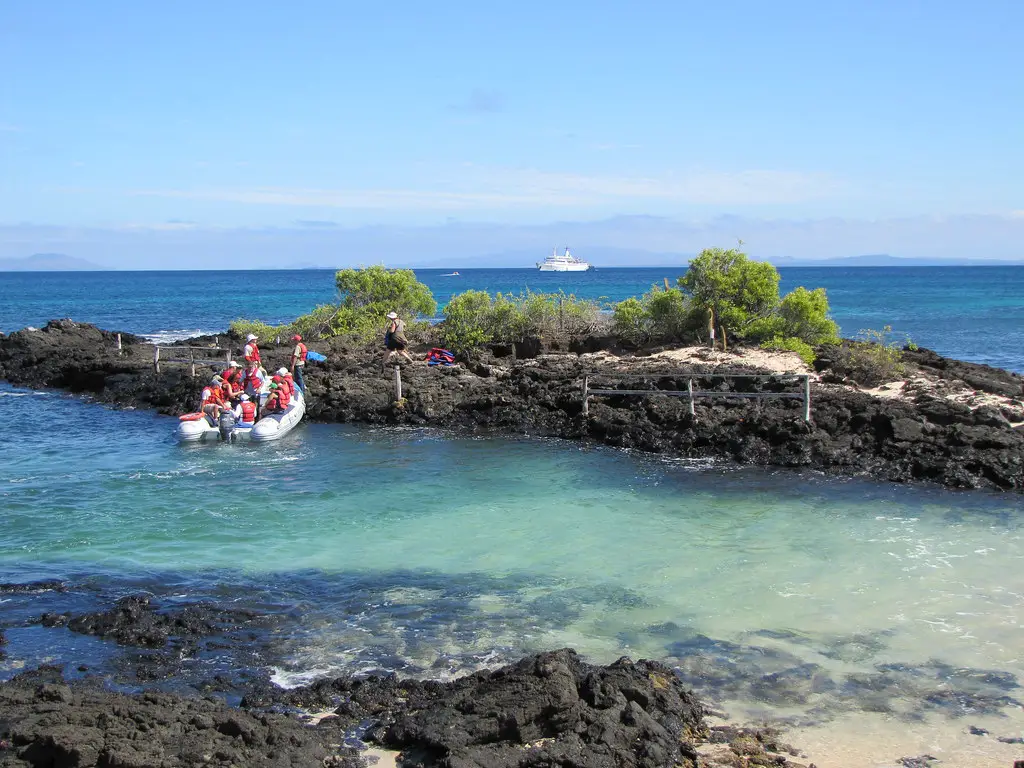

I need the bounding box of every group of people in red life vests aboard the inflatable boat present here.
[200,334,308,426]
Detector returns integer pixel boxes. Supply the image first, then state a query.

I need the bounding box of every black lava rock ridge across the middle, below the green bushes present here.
[0,319,1024,493]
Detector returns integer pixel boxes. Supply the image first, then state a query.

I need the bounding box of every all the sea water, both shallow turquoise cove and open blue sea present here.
[0,267,1024,768]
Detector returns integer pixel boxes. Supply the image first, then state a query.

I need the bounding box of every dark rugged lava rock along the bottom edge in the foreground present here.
[0,649,724,768]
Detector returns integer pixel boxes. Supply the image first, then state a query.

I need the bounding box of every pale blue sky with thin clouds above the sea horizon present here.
[0,0,1024,268]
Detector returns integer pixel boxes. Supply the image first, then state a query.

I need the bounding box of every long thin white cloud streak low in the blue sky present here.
[132,165,846,211]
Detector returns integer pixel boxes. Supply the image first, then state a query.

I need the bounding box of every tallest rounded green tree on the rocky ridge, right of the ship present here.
[679,248,779,335]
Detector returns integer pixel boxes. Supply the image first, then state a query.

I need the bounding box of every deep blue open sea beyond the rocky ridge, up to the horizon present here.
[0,265,1024,372]
